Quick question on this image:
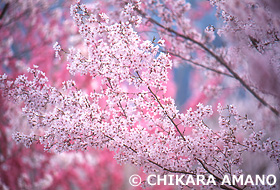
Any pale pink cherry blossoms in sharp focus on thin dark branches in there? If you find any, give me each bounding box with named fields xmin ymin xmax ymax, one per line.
xmin=0 ymin=0 xmax=280 ymax=189
